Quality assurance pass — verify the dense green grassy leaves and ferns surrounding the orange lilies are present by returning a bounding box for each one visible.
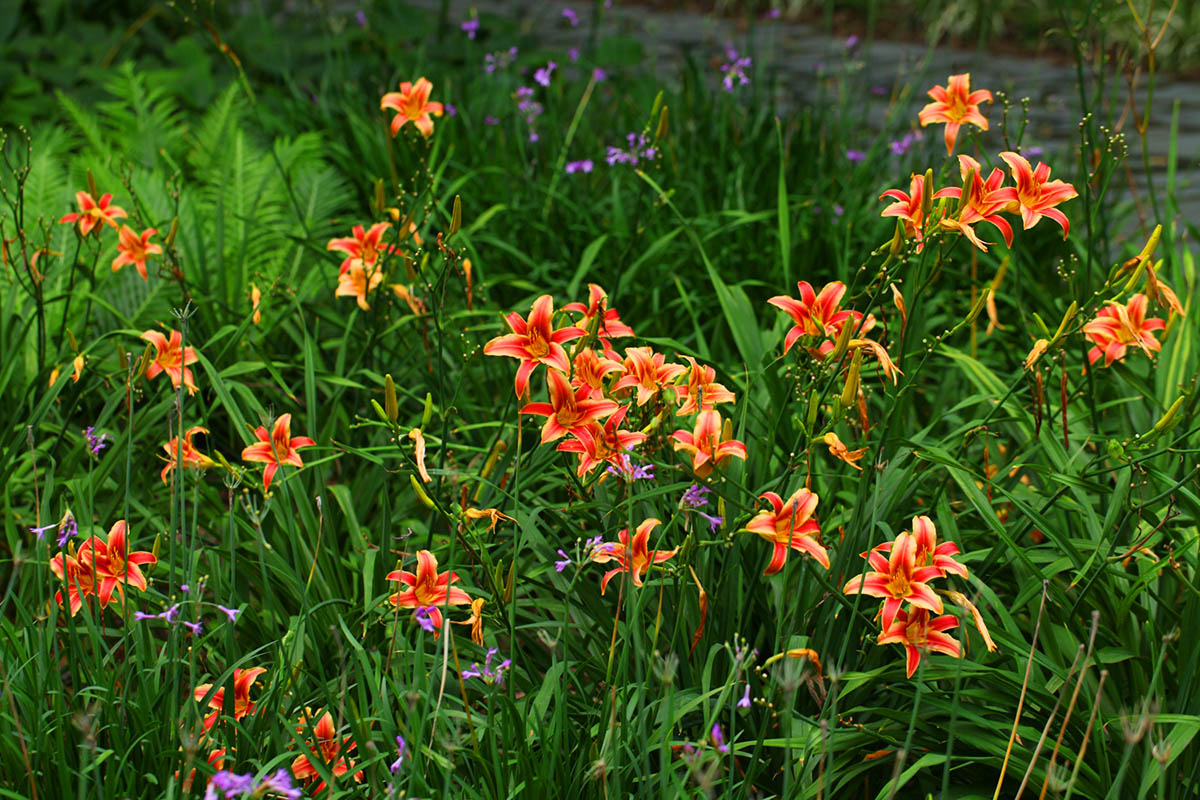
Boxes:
[0,4,1200,799]
